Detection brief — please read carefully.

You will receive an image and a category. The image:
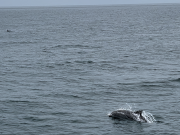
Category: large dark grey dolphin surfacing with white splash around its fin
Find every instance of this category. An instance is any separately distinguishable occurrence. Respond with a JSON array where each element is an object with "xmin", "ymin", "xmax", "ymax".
[{"xmin": 109, "ymin": 110, "xmax": 147, "ymax": 122}]
